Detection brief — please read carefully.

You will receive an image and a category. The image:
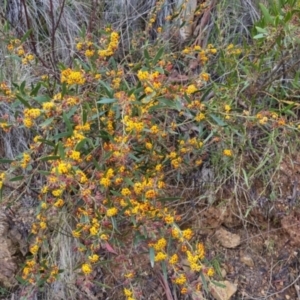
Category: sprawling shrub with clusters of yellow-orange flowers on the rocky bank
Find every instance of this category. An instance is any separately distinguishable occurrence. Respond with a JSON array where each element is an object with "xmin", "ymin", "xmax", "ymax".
[{"xmin": 0, "ymin": 1, "xmax": 298, "ymax": 300}]
